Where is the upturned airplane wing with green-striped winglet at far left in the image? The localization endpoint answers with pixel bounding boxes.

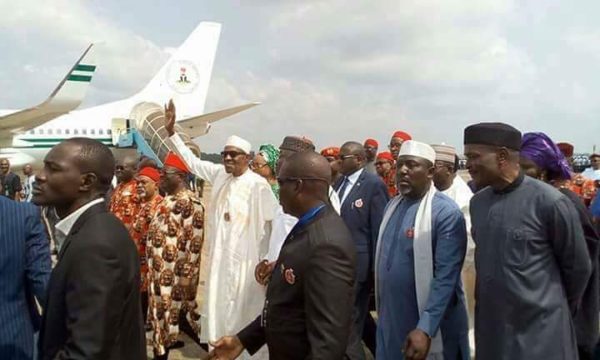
[0,44,96,140]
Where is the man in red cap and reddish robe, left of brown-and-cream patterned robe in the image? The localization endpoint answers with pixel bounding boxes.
[130,167,163,322]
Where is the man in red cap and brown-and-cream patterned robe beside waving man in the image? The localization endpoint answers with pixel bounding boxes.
[147,153,204,360]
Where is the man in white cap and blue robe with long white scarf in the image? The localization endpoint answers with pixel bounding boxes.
[375,140,470,360]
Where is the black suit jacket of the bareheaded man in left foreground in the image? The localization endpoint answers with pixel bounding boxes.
[40,203,146,360]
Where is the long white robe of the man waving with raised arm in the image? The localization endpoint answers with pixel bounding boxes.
[170,134,279,359]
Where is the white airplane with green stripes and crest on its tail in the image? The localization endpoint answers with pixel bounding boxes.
[0,22,258,168]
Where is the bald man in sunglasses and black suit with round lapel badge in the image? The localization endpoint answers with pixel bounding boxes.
[210,151,356,360]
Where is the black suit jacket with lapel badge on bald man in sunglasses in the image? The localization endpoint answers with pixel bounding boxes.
[238,207,356,360]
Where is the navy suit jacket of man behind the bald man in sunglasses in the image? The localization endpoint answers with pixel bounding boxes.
[335,170,390,282]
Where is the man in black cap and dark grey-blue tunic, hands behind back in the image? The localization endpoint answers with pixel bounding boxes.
[464,123,592,360]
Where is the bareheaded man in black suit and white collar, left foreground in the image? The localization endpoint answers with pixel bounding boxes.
[33,138,146,360]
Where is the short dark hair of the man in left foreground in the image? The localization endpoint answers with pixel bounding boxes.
[64,137,115,193]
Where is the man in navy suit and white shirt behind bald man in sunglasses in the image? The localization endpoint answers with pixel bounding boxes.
[335,141,389,360]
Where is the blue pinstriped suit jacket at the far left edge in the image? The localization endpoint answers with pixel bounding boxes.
[0,197,51,360]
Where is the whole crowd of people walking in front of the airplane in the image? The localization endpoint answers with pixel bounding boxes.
[0,102,600,360]
